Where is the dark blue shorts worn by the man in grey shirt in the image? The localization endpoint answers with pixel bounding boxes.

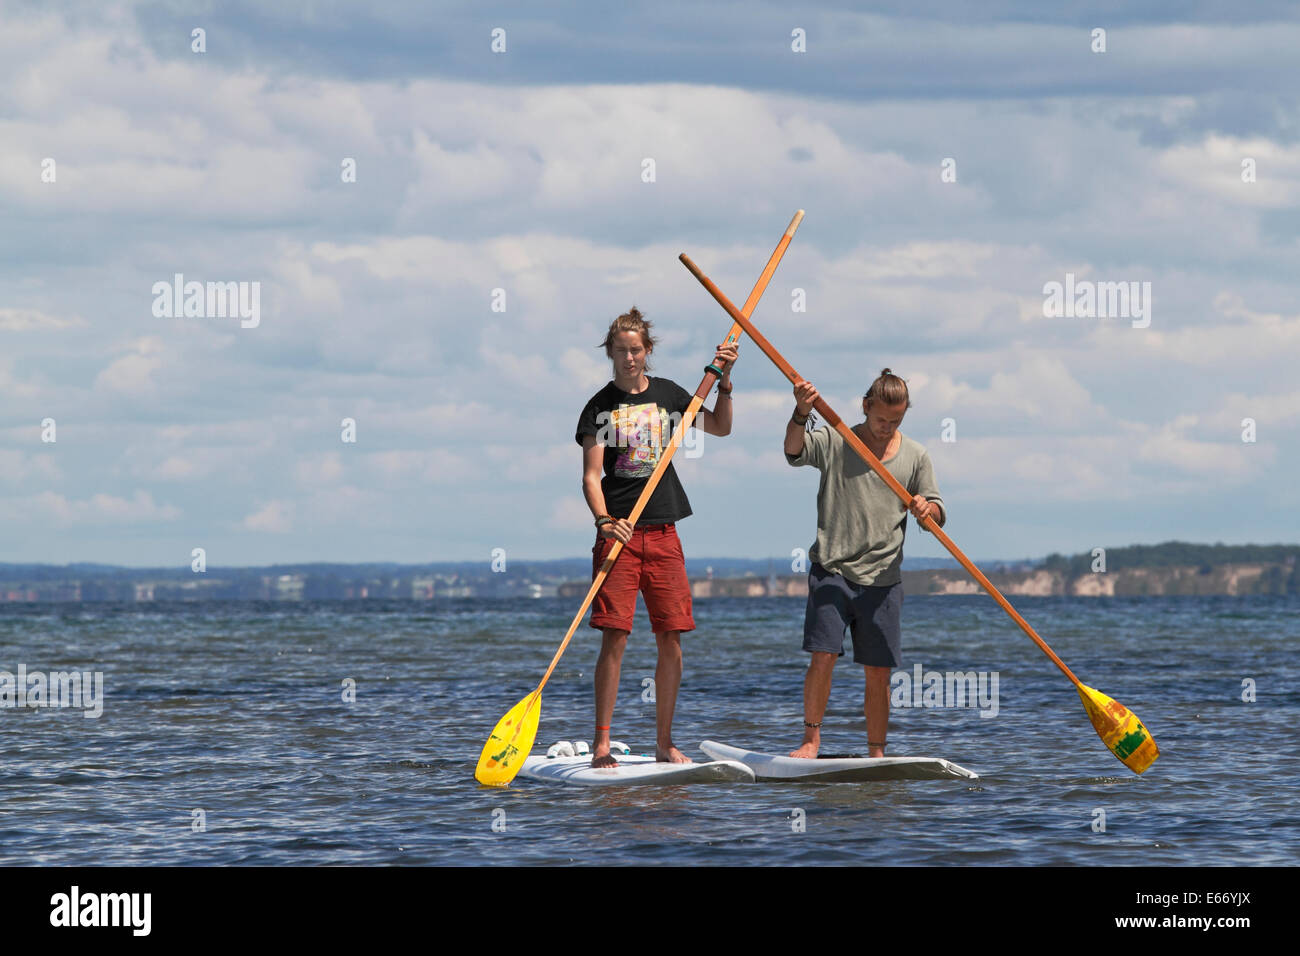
[803,563,902,667]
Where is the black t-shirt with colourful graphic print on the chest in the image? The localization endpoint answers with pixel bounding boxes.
[573,376,692,525]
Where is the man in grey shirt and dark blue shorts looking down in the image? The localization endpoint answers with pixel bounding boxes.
[785,368,948,757]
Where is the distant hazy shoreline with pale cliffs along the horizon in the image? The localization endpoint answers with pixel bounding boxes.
[0,541,1300,604]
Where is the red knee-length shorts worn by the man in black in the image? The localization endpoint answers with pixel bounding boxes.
[590,524,696,633]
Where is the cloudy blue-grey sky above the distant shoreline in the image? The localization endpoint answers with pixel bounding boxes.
[0,0,1300,566]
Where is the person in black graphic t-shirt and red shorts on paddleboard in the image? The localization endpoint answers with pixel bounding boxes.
[575,308,737,767]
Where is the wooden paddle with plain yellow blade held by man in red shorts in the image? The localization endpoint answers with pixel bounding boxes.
[475,209,803,787]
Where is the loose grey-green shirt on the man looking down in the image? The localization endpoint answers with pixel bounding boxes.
[785,428,948,587]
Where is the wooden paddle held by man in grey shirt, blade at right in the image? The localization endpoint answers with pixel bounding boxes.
[680,252,1160,774]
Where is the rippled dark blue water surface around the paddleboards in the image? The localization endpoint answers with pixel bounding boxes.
[0,596,1300,866]
